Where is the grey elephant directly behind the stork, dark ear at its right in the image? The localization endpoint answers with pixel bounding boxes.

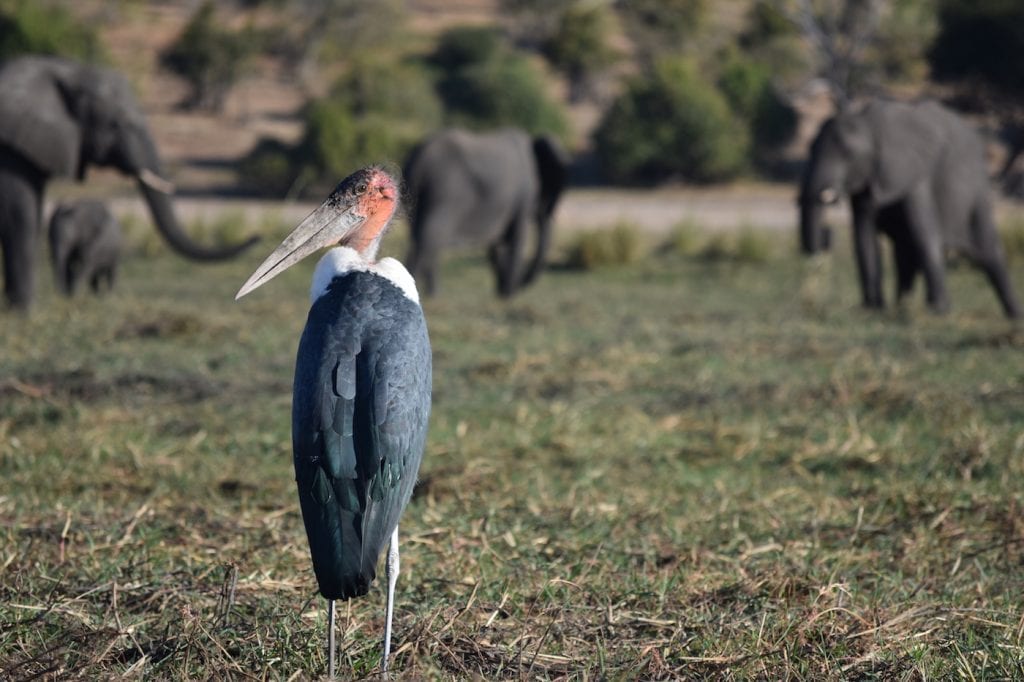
[404,128,567,297]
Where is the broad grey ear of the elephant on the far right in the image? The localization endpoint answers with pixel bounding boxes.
[865,101,944,204]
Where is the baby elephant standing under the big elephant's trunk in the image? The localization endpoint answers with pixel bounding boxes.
[50,200,121,296]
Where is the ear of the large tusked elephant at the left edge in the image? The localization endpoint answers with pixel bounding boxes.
[0,57,82,176]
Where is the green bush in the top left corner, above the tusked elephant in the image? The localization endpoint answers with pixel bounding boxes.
[0,0,105,61]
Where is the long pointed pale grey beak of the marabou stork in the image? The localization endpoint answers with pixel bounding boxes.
[234,200,366,301]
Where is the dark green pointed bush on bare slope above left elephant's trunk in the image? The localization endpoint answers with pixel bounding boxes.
[160,0,253,112]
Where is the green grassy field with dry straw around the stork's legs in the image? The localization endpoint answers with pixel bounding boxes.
[0,220,1024,680]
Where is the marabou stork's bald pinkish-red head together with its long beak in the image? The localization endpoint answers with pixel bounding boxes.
[234,166,398,300]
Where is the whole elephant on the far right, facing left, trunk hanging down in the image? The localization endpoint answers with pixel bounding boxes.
[799,99,1021,318]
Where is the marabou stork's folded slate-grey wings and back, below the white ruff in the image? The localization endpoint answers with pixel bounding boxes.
[292,272,431,599]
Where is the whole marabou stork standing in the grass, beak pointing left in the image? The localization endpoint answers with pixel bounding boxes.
[236,167,431,678]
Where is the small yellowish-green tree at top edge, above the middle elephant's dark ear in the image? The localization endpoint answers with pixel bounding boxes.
[543,2,620,101]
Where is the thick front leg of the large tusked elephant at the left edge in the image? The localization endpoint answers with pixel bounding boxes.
[0,162,42,309]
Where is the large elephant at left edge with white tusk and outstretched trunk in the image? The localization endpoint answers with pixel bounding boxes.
[0,56,259,309]
